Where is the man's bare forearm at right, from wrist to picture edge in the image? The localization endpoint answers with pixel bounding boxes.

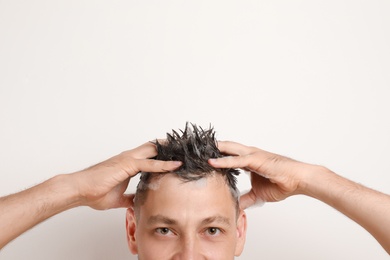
[301,166,390,254]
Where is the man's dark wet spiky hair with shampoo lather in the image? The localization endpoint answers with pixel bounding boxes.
[134,122,240,214]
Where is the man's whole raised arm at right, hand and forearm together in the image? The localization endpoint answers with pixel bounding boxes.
[209,142,390,254]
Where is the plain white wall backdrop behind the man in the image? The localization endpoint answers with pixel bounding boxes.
[0,0,390,260]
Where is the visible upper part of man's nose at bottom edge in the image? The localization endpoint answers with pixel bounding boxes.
[172,236,205,260]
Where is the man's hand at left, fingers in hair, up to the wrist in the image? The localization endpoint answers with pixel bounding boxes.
[71,142,181,210]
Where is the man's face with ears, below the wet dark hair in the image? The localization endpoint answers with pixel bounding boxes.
[126,174,246,260]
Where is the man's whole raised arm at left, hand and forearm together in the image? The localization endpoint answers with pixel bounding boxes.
[0,143,181,249]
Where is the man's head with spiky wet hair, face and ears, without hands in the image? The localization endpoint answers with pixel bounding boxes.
[127,124,246,260]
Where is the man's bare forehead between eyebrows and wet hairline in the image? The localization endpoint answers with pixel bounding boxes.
[140,174,236,220]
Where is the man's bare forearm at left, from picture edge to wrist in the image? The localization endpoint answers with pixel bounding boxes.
[0,175,79,249]
